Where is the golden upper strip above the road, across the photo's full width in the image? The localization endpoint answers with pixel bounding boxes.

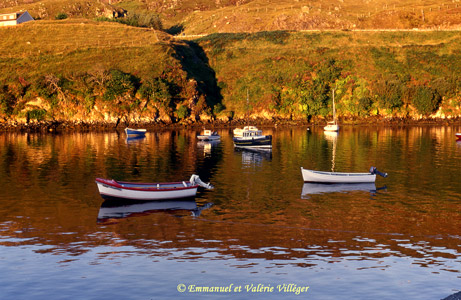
[0,0,461,34]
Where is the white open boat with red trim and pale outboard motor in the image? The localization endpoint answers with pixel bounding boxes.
[96,175,213,201]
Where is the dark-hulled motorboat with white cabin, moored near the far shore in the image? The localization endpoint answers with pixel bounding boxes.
[234,126,272,148]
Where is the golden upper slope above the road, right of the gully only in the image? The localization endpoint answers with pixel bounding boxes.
[178,0,461,34]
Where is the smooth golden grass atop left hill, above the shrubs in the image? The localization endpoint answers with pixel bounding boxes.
[0,20,174,79]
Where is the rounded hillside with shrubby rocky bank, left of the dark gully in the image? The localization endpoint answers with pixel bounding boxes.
[0,20,219,122]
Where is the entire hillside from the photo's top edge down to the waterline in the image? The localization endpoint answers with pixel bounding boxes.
[0,0,461,124]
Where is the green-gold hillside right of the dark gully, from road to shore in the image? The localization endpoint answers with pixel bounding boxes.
[196,31,461,119]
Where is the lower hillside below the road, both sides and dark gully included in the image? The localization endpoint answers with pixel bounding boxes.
[0,21,461,124]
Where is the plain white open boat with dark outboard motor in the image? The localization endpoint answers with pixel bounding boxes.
[301,167,387,183]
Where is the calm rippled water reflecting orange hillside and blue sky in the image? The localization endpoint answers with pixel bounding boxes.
[0,126,461,300]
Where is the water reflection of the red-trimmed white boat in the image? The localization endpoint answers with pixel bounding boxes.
[97,197,213,223]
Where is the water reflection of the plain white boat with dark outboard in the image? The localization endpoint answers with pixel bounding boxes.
[301,182,386,199]
